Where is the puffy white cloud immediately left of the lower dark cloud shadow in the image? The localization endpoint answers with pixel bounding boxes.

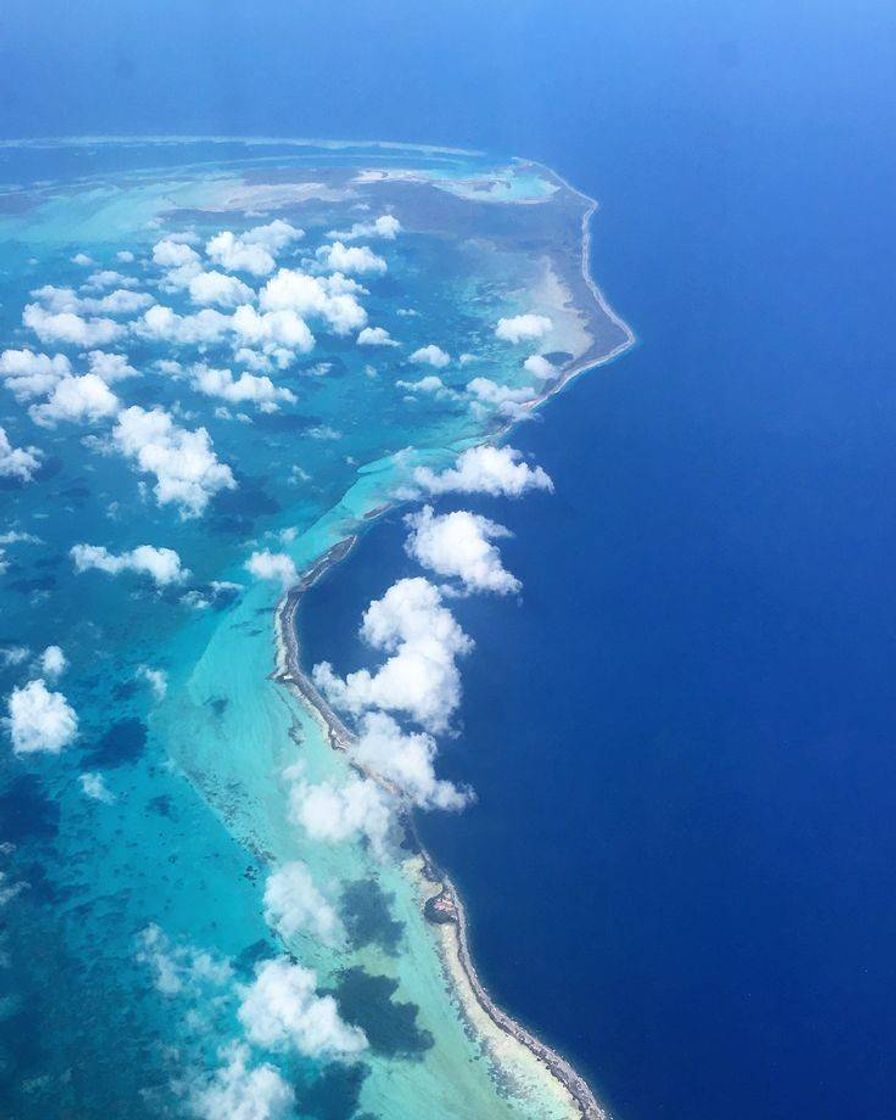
[237,956,367,1060]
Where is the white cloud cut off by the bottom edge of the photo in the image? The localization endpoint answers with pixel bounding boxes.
[190,1046,295,1120]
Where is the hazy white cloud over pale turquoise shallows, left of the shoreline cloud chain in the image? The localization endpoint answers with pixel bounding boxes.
[289,776,392,855]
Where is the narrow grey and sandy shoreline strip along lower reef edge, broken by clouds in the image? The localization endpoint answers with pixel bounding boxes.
[271,534,610,1120]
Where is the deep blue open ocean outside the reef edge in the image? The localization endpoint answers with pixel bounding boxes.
[0,0,896,1120]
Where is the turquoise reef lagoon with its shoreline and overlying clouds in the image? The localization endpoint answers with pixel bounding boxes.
[0,138,633,1120]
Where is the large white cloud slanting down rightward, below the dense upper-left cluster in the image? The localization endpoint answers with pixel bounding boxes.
[112,404,236,517]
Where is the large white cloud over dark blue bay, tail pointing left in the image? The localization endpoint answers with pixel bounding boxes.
[312,577,473,732]
